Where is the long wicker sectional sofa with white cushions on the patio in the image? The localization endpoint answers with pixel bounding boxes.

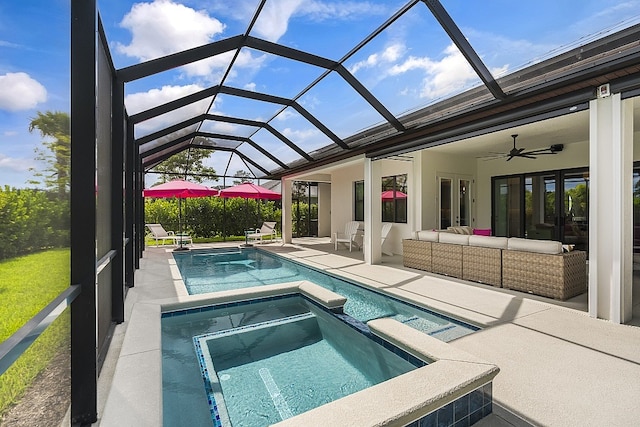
[403,231,587,300]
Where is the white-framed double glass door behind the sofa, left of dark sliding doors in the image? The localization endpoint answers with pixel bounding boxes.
[438,174,473,230]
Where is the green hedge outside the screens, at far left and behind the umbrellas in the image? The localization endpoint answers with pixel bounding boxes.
[0,186,307,260]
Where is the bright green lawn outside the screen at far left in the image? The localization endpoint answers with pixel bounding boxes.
[0,249,71,416]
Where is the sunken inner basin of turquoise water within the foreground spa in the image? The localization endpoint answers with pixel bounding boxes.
[194,302,416,426]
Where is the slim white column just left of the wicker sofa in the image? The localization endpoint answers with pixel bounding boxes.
[363,157,382,264]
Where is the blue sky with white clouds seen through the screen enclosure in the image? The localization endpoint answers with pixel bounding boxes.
[0,0,640,187]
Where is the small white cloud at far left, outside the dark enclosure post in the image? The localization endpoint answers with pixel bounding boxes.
[0,73,47,111]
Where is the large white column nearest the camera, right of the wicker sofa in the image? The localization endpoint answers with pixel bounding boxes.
[589,94,633,323]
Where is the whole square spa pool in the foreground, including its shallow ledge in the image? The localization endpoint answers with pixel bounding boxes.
[162,295,426,426]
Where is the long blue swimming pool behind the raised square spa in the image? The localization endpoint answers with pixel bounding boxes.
[174,248,479,342]
